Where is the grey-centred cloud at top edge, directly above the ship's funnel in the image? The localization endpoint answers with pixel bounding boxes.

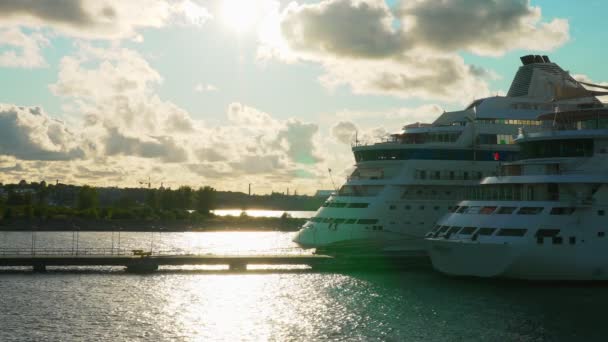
[400,0,570,56]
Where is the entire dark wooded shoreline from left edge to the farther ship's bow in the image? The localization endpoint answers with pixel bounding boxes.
[0,180,325,223]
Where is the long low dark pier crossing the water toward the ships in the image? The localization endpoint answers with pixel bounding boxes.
[0,250,428,273]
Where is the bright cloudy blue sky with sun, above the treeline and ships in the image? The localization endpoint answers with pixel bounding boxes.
[0,0,608,193]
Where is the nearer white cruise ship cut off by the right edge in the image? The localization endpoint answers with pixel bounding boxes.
[428,107,608,280]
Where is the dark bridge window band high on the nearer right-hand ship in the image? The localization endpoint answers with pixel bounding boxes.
[520,139,593,159]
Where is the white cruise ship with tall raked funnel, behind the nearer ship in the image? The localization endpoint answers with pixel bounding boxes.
[294,55,600,254]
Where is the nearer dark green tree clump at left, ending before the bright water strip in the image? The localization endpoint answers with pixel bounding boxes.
[0,181,216,221]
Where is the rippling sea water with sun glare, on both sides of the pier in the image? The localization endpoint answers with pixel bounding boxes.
[0,232,608,341]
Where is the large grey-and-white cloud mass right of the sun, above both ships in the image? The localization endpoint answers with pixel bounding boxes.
[258,0,569,103]
